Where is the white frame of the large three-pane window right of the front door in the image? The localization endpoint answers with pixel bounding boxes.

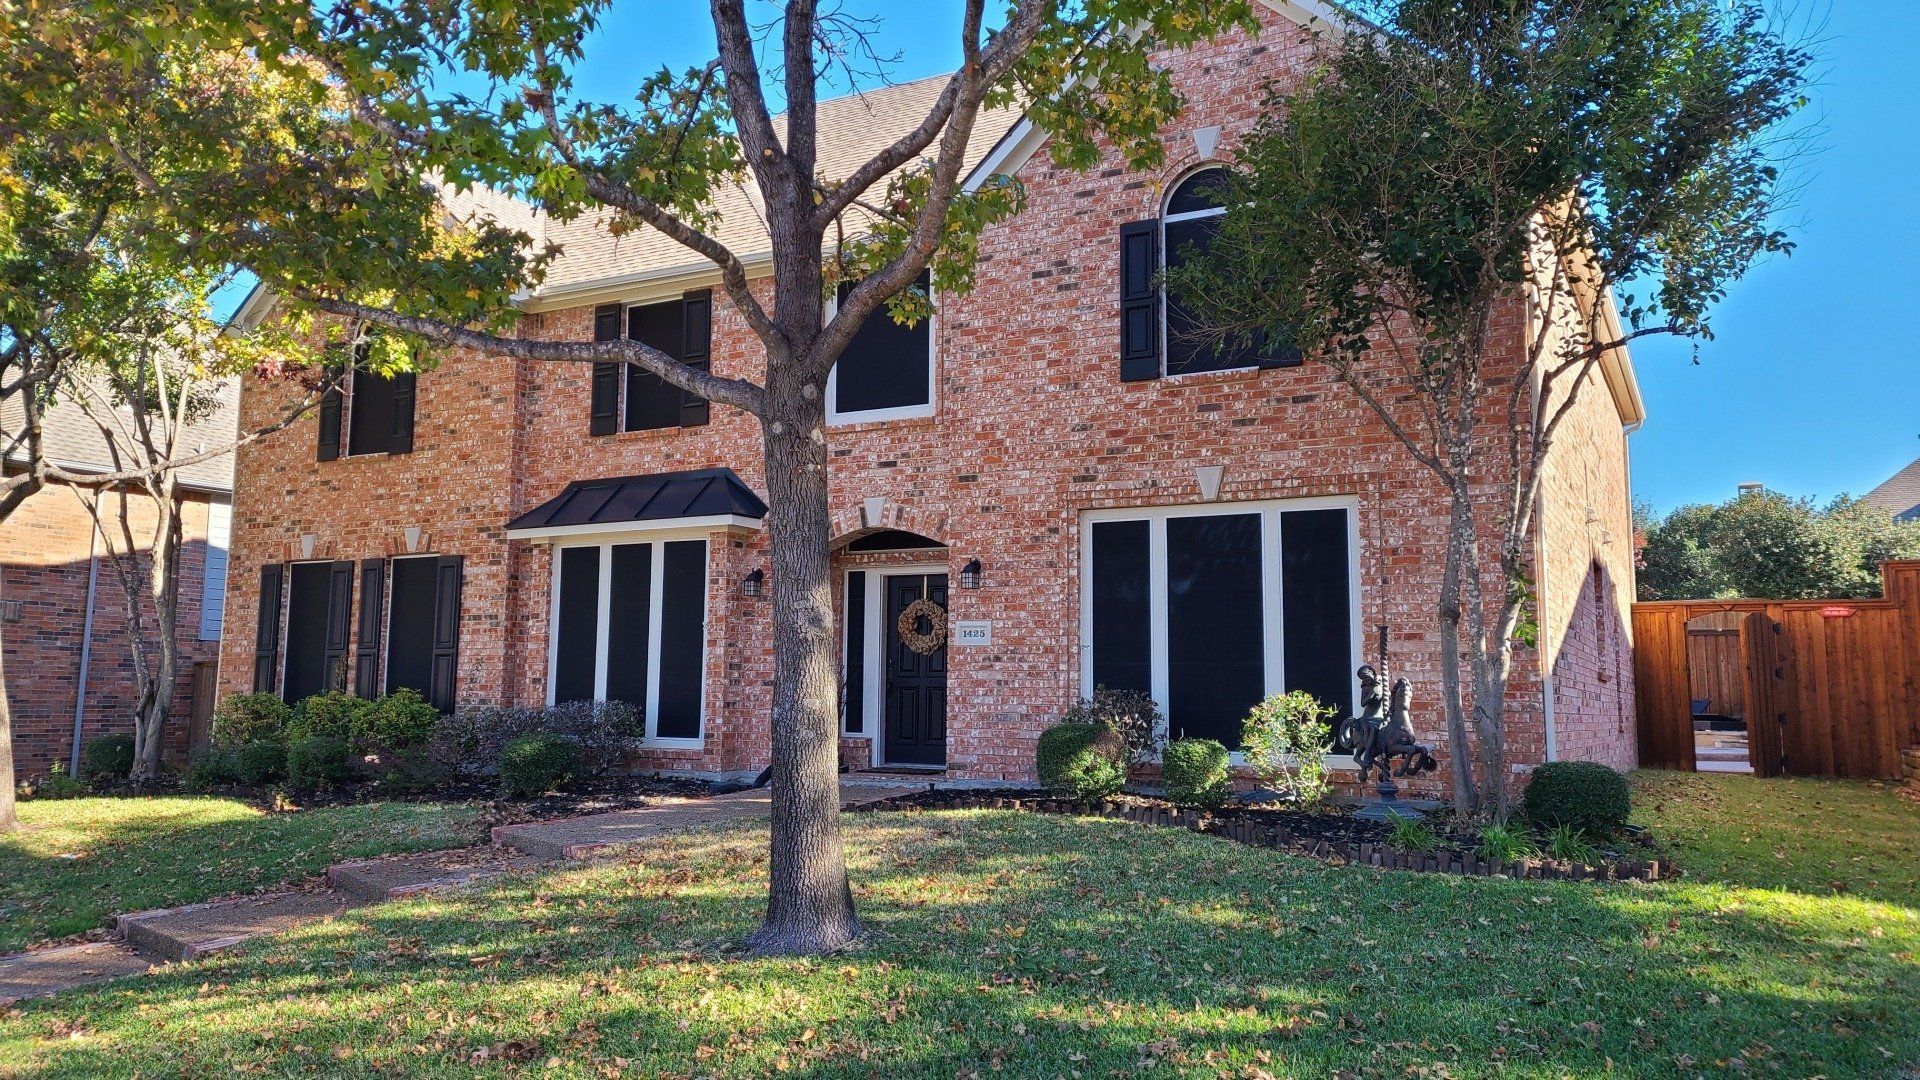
[1079,496,1365,769]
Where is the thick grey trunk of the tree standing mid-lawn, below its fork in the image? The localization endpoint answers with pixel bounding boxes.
[747,386,860,955]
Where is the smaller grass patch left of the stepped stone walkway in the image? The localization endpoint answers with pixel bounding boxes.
[0,798,480,955]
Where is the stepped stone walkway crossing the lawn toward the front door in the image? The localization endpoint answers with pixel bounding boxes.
[0,782,924,1005]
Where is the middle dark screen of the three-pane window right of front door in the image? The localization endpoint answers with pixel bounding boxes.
[1167,513,1265,749]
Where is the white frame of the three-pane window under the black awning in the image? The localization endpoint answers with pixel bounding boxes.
[547,528,714,749]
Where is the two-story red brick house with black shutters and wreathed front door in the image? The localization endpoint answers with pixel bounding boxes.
[221,0,1642,784]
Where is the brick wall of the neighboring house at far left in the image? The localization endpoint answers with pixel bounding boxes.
[0,472,217,778]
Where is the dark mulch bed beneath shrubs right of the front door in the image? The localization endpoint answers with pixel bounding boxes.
[858,790,1678,882]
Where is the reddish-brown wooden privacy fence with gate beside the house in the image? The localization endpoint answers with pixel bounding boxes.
[1634,561,1920,780]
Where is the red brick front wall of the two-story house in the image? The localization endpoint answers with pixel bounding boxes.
[223,6,1624,780]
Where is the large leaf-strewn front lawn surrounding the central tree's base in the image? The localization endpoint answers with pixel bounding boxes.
[0,768,1920,1078]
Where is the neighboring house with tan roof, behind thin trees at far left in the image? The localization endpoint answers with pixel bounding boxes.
[0,382,240,776]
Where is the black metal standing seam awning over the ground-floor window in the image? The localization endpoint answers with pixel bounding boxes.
[507,469,766,542]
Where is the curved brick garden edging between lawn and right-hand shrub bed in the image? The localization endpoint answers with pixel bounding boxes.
[858,796,1676,882]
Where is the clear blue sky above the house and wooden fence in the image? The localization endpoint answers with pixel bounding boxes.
[445,0,1920,511]
